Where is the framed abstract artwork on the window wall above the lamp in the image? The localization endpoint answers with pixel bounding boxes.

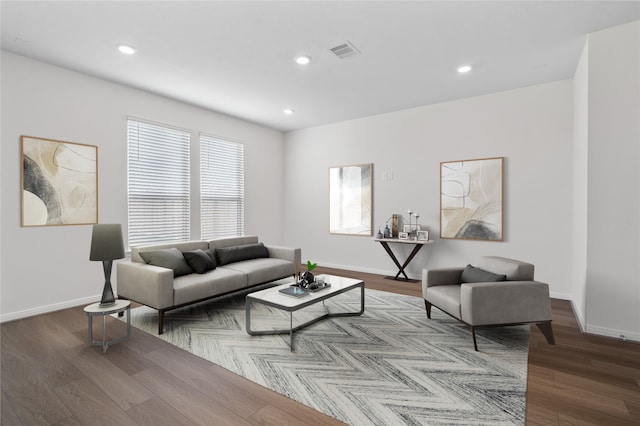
[20,135,98,227]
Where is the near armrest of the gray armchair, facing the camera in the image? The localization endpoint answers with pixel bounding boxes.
[460,281,551,325]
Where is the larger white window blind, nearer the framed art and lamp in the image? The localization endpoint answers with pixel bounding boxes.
[127,119,191,247]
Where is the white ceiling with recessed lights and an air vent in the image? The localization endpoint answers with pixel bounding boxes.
[0,0,640,131]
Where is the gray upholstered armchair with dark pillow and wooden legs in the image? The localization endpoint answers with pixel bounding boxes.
[422,256,555,351]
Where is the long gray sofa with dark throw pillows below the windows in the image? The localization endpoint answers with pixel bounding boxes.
[117,236,301,334]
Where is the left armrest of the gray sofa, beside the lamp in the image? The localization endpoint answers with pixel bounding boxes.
[117,262,173,309]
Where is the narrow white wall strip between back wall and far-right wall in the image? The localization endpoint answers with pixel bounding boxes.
[572,41,589,330]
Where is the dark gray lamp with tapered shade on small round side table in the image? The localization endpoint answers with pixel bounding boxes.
[89,223,124,306]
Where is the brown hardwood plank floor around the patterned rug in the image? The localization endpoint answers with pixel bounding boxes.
[0,268,640,426]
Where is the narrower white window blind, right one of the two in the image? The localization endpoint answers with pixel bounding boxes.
[200,135,244,240]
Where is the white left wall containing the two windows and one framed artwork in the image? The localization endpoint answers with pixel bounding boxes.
[0,51,284,321]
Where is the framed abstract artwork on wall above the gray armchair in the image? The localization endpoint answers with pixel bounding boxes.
[440,157,504,241]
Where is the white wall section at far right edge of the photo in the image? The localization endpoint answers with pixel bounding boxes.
[586,21,640,341]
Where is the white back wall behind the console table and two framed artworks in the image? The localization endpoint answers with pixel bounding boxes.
[284,80,573,298]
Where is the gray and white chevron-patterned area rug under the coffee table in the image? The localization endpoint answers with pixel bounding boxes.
[125,290,529,426]
